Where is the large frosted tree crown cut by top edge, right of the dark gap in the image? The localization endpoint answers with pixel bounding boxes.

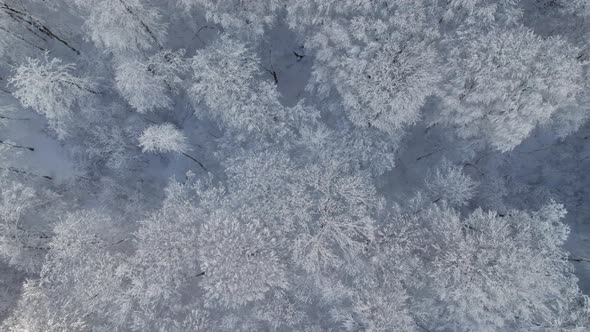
[289,1,439,134]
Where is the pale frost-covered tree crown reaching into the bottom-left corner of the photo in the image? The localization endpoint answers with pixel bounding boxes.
[4,211,125,331]
